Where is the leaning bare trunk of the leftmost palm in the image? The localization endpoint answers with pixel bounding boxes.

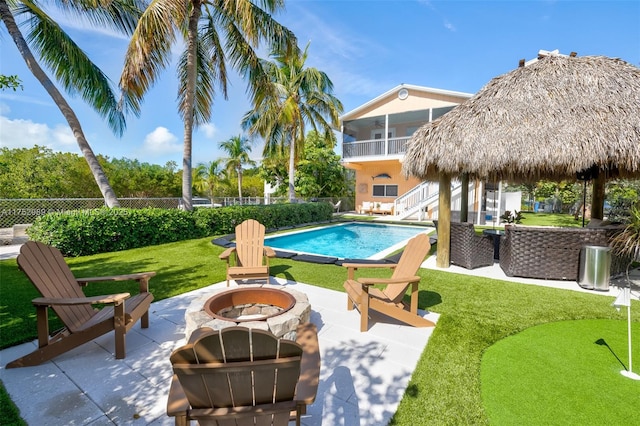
[0,0,120,207]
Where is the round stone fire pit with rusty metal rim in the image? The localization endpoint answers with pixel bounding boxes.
[185,285,311,340]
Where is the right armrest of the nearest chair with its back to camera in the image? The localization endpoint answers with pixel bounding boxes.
[296,323,320,404]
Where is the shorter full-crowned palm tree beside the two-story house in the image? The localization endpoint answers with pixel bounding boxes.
[242,44,342,202]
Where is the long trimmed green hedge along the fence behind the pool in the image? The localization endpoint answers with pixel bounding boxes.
[27,203,333,256]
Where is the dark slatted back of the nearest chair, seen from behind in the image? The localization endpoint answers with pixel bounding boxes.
[171,327,302,412]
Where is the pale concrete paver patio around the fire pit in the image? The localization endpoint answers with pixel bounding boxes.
[0,278,438,426]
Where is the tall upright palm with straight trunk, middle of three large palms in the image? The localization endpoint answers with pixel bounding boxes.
[120,0,295,210]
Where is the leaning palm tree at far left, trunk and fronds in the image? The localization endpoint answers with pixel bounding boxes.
[0,0,139,207]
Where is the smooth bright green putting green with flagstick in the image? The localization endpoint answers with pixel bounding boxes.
[480,320,640,426]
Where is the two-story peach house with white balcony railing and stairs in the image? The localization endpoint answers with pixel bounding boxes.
[340,84,478,218]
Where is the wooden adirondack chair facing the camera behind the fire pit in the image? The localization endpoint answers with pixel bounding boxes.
[219,219,276,287]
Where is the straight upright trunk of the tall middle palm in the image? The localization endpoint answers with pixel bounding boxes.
[182,0,202,210]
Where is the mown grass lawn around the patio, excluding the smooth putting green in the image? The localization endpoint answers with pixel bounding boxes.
[0,216,640,425]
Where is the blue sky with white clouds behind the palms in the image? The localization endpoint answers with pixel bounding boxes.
[0,0,640,164]
